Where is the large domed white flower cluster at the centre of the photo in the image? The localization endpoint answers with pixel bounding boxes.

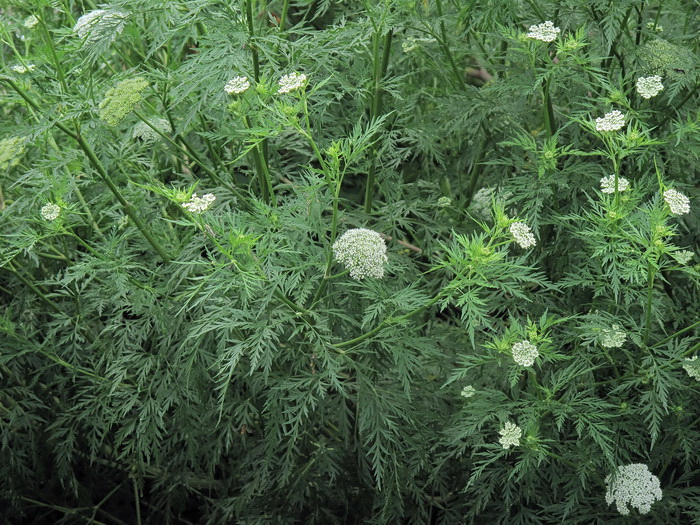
[333,228,388,281]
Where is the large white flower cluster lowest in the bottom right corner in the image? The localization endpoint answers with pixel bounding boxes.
[605,463,661,516]
